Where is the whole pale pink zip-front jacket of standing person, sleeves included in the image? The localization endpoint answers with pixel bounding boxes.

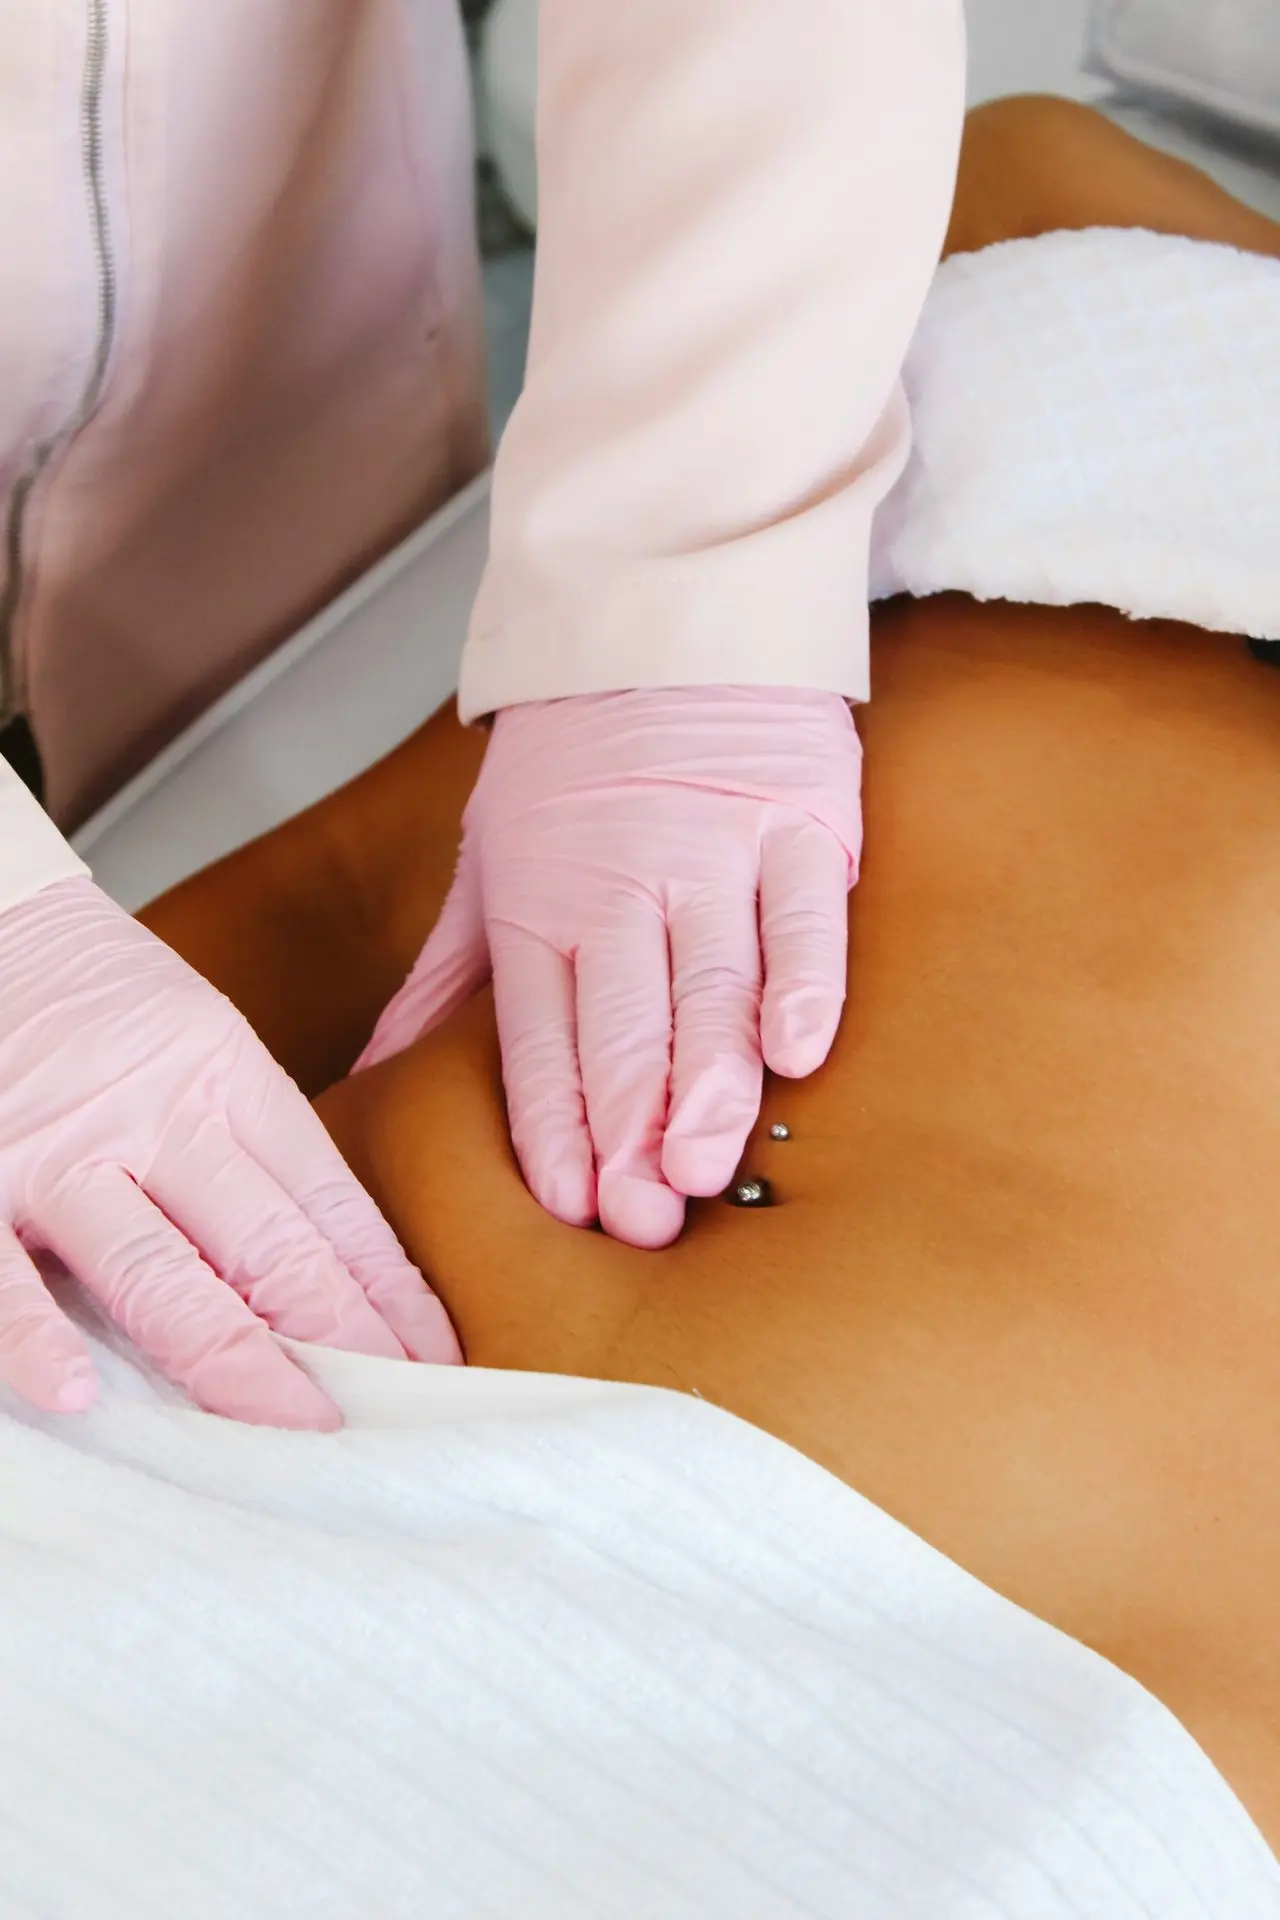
[0,0,963,908]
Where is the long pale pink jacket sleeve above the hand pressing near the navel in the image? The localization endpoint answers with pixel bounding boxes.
[461,0,965,718]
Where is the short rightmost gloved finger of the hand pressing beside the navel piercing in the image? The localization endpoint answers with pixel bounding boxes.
[760,820,850,1079]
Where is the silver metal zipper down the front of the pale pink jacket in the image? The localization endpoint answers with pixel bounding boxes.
[0,0,117,726]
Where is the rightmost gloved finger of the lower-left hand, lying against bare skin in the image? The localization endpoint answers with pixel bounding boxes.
[228,1054,462,1365]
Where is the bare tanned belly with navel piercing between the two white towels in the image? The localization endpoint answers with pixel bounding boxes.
[326,599,1280,1851]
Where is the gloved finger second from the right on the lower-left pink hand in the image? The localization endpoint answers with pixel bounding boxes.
[146,1119,405,1359]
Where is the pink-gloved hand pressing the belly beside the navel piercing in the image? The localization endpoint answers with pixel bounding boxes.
[357,687,862,1246]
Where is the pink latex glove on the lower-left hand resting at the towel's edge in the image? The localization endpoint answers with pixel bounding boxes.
[0,879,461,1428]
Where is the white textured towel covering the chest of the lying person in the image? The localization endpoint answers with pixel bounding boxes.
[871,228,1280,639]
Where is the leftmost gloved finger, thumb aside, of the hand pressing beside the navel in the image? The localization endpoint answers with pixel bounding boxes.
[491,925,597,1227]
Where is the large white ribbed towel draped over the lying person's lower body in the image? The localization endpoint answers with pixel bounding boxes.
[0,1297,1280,1920]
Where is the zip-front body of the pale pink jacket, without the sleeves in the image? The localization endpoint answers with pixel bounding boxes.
[0,0,487,840]
